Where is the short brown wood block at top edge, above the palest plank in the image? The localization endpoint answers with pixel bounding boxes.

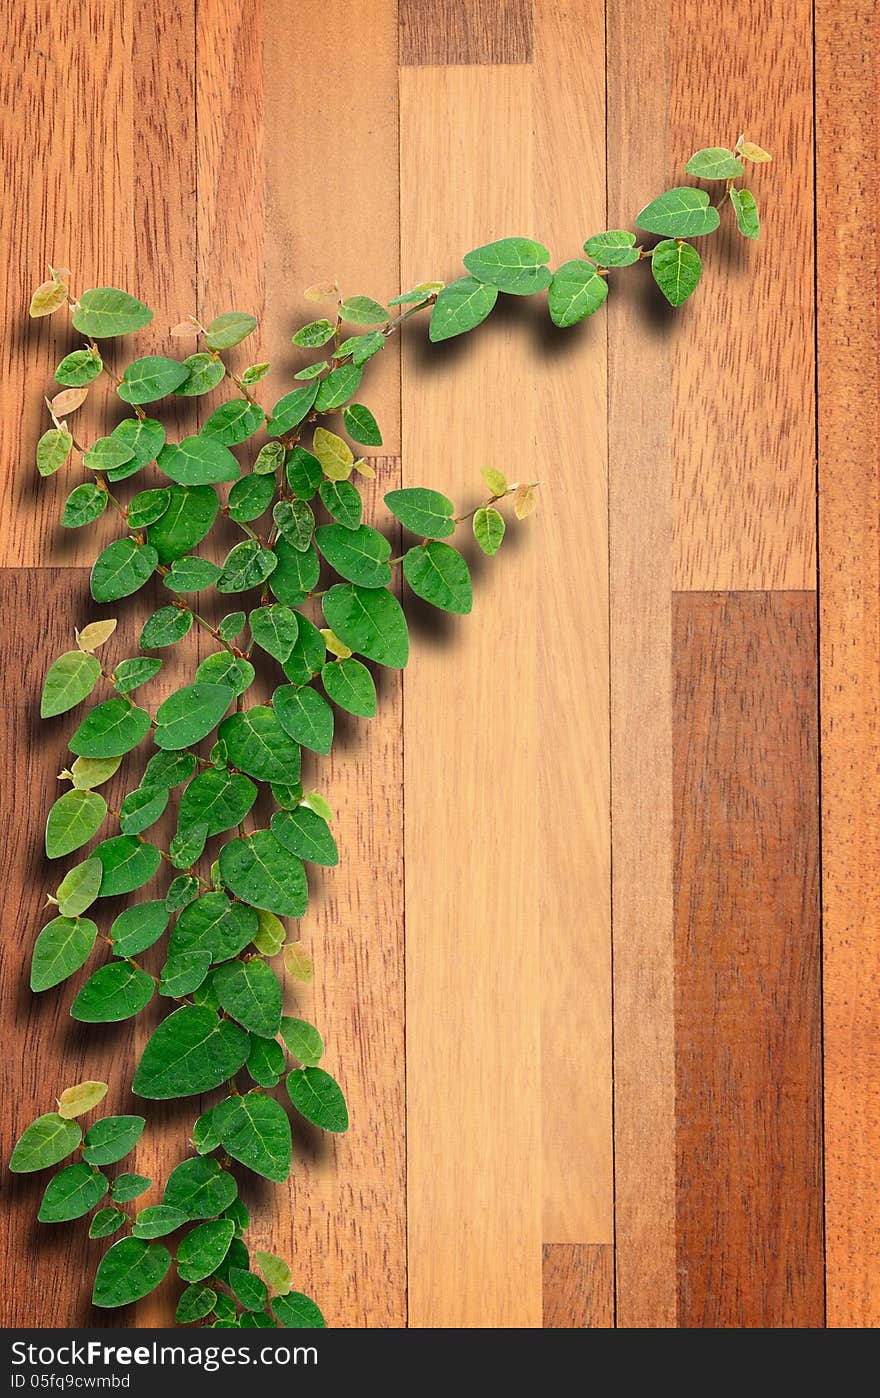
[399,0,528,64]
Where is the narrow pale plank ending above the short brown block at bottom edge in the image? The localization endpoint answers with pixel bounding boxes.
[525,0,614,1243]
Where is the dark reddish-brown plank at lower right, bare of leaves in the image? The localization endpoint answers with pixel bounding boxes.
[673,593,824,1329]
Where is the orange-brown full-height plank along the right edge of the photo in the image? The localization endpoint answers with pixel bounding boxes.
[816,0,880,1328]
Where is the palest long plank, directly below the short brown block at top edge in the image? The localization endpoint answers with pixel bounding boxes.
[400,67,548,1327]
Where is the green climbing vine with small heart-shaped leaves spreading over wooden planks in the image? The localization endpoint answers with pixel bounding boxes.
[10,138,769,1328]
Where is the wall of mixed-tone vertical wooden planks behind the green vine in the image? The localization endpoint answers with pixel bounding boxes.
[0,0,880,1328]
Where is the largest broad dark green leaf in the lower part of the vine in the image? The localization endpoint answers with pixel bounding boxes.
[132,1005,250,1101]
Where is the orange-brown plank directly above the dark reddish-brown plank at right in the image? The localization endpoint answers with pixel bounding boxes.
[668,0,816,590]
